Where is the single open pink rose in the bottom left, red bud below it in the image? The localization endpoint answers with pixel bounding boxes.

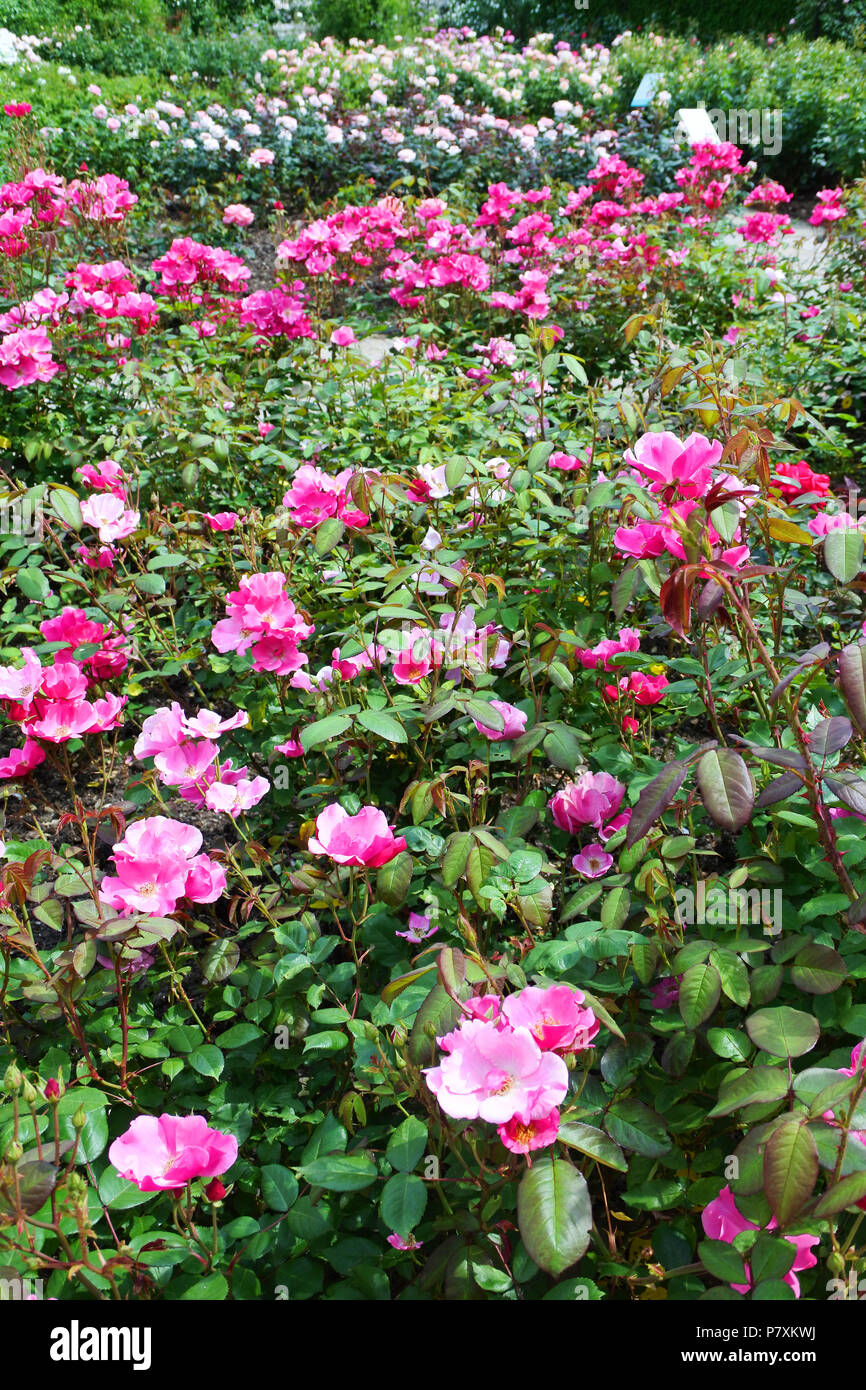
[108,1115,238,1193]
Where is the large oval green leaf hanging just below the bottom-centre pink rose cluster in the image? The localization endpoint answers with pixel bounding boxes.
[517,1158,592,1276]
